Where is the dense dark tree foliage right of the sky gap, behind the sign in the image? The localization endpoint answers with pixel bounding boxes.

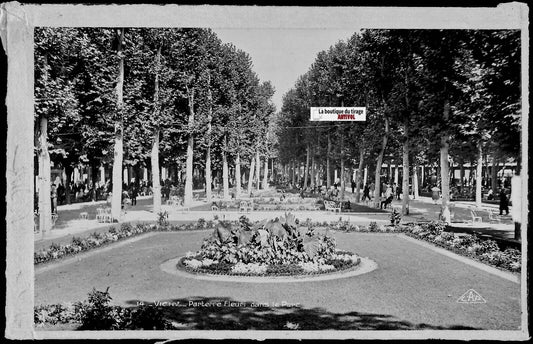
[276,29,521,214]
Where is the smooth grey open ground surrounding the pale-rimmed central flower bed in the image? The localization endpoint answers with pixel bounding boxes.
[35,232,520,330]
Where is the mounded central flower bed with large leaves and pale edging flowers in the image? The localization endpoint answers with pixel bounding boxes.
[177,214,360,276]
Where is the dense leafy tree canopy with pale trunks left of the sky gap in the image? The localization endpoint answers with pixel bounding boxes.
[35,28,275,222]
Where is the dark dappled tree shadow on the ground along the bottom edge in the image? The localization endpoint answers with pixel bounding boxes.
[127,297,476,330]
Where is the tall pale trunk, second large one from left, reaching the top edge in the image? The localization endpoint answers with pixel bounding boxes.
[111,29,124,220]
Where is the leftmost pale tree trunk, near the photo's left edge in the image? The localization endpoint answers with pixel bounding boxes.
[39,116,52,234]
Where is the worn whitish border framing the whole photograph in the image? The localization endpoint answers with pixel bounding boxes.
[0,2,529,340]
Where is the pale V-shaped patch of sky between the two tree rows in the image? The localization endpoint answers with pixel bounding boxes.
[213,28,359,111]
